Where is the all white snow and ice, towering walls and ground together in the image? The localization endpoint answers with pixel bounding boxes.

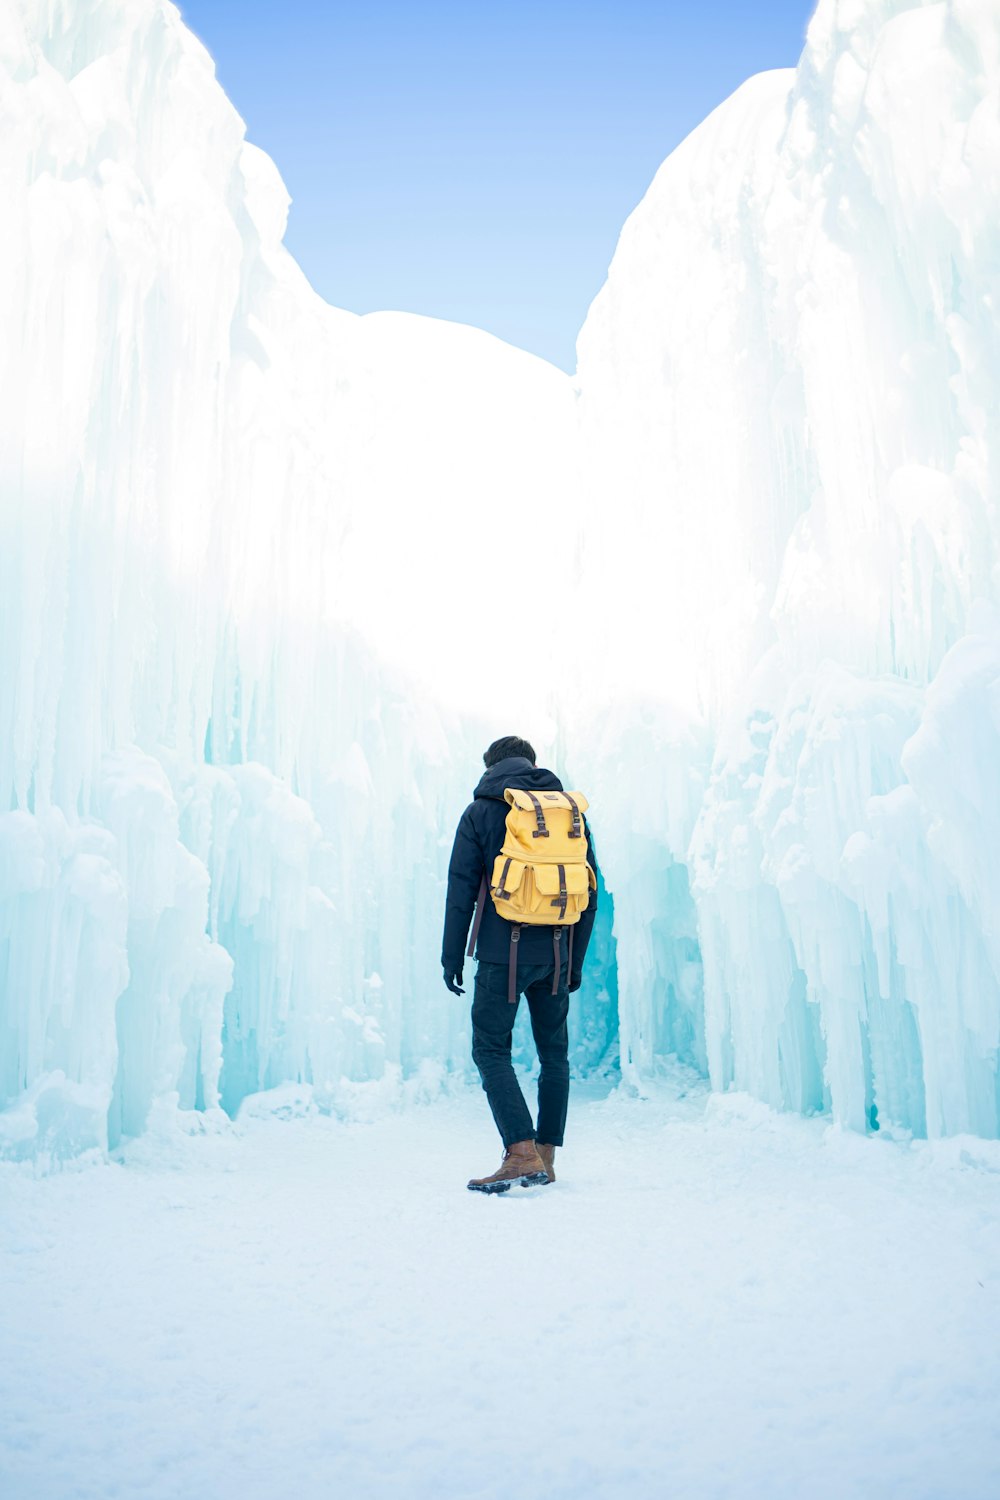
[0,0,1000,1500]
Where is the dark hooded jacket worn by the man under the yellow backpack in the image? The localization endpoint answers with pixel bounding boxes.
[441,756,597,981]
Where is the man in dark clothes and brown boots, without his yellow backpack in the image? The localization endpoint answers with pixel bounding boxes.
[441,735,597,1193]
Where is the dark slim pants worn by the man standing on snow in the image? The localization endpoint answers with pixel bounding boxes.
[472,962,570,1146]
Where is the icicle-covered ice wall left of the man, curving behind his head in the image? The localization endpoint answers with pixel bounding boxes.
[0,0,593,1160]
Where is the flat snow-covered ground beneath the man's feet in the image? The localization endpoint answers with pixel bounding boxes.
[0,1079,1000,1500]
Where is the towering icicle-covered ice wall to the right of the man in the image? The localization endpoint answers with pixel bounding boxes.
[579,0,1000,1136]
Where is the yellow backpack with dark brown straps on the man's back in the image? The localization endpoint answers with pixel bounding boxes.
[468,786,597,1005]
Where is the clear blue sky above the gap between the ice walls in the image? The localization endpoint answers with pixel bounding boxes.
[181,0,813,371]
